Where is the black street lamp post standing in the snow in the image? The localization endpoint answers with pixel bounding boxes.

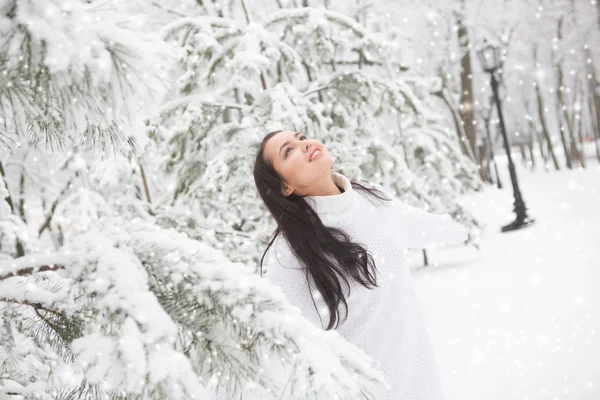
[477,44,535,232]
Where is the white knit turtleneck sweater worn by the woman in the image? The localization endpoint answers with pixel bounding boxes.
[265,173,467,400]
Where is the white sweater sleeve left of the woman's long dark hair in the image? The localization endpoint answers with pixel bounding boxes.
[265,238,329,329]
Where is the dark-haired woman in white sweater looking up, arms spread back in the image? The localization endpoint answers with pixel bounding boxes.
[254,130,467,400]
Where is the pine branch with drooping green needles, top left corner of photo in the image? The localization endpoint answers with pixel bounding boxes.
[0,1,166,154]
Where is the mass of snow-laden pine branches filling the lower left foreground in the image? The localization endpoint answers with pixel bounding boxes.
[0,219,383,400]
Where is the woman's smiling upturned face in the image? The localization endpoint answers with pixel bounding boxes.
[264,131,333,196]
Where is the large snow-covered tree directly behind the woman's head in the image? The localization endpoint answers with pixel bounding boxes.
[149,2,481,272]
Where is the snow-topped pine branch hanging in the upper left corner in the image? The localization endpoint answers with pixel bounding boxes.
[0,0,171,153]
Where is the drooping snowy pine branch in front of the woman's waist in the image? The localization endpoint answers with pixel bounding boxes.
[129,220,382,399]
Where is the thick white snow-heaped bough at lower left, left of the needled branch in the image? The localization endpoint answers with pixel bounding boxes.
[55,228,208,399]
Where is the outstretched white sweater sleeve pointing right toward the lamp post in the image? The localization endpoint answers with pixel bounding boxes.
[375,184,468,249]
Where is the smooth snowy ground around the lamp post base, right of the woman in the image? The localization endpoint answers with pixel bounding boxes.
[413,155,600,400]
